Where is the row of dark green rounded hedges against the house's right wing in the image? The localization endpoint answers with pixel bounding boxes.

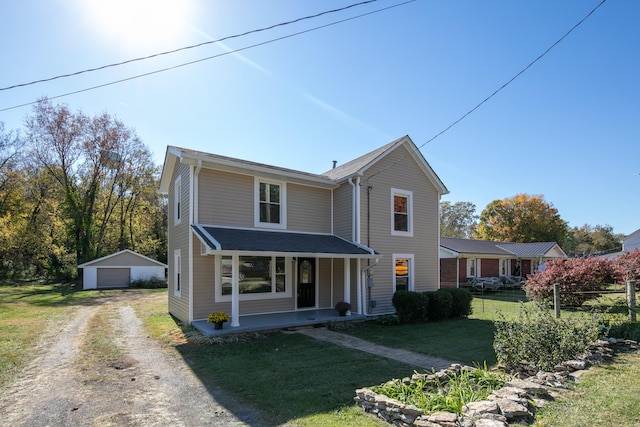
[392,288,473,323]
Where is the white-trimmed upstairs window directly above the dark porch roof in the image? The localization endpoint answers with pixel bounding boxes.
[255,178,286,228]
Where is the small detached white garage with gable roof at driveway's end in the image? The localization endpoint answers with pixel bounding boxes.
[78,249,167,289]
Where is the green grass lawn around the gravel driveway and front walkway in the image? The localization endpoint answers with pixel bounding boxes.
[0,285,640,427]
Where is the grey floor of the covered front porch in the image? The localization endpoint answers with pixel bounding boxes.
[192,308,367,337]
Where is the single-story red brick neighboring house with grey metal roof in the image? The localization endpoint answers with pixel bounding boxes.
[440,237,567,288]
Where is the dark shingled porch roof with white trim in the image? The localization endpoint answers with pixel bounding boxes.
[193,224,380,258]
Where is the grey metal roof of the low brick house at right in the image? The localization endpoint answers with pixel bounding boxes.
[440,237,567,258]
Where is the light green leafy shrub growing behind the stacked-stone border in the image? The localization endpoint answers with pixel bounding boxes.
[493,303,601,371]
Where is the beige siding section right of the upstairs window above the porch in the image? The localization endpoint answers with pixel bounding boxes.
[287,184,331,233]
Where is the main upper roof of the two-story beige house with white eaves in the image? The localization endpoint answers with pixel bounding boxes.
[159,136,449,195]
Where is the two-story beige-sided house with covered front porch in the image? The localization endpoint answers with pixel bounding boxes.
[160,136,447,327]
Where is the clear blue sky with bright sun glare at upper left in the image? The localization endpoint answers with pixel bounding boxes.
[0,0,640,235]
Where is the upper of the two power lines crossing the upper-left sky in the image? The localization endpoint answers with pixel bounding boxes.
[0,0,378,91]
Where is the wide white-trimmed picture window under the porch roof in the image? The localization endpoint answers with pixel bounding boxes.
[216,255,292,301]
